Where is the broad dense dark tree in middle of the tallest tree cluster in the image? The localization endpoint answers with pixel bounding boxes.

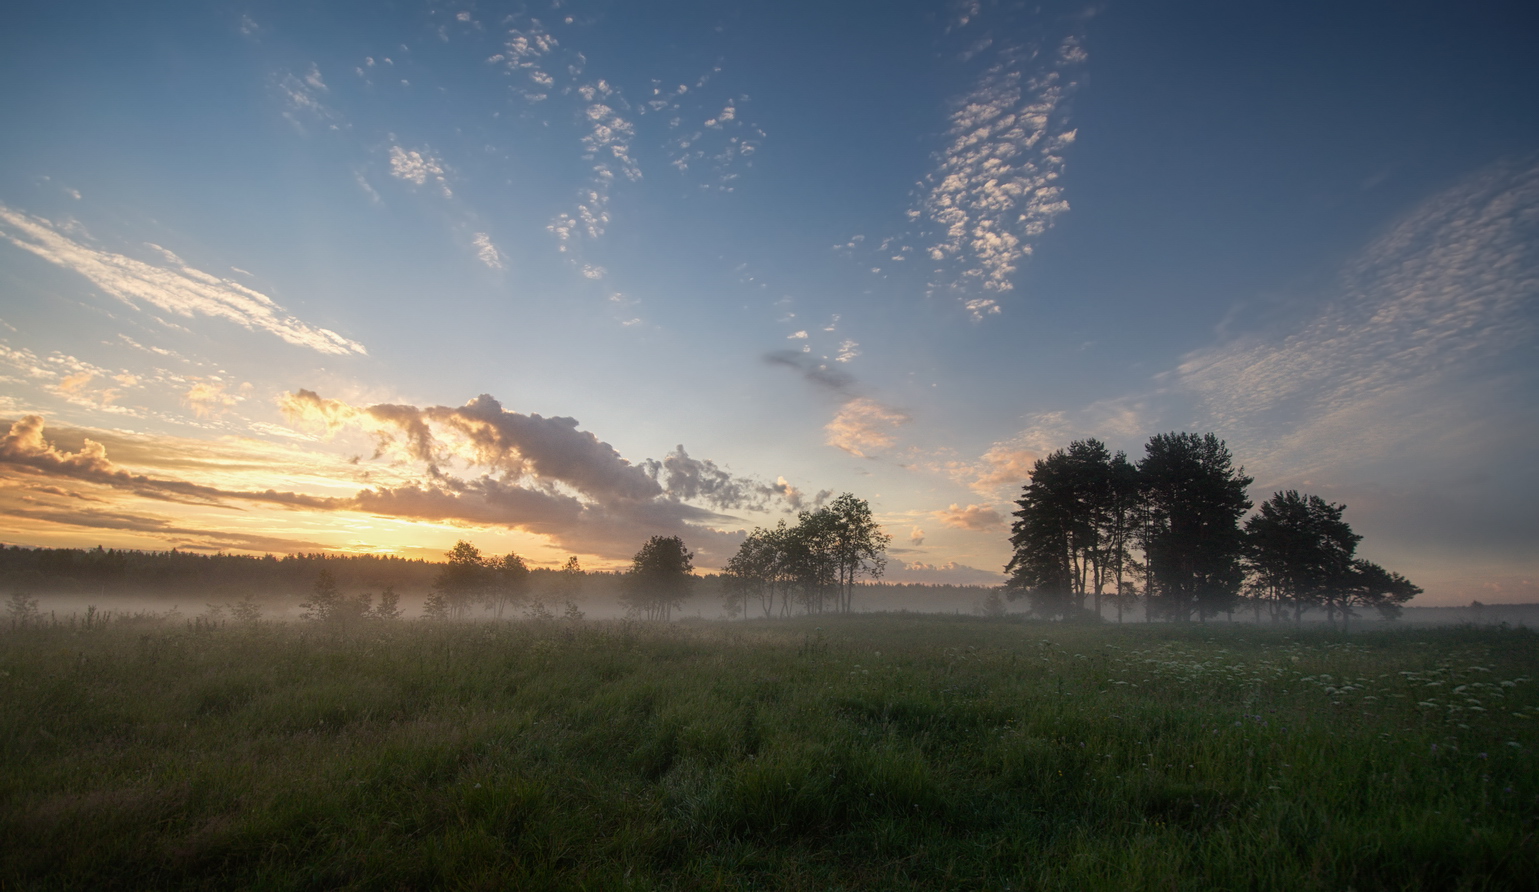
[1137,434,1253,620]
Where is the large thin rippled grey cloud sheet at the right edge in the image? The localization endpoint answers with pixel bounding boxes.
[1163,163,1539,472]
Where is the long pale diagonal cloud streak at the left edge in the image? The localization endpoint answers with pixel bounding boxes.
[0,205,368,355]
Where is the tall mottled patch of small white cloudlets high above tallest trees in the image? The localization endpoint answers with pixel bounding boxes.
[919,32,1085,320]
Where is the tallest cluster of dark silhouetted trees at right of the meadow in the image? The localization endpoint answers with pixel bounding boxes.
[1005,434,1420,623]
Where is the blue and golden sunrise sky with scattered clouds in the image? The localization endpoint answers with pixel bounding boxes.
[0,0,1539,604]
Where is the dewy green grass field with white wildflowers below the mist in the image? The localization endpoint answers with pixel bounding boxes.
[0,615,1539,890]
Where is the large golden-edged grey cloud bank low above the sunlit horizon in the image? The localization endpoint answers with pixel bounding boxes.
[0,402,769,566]
